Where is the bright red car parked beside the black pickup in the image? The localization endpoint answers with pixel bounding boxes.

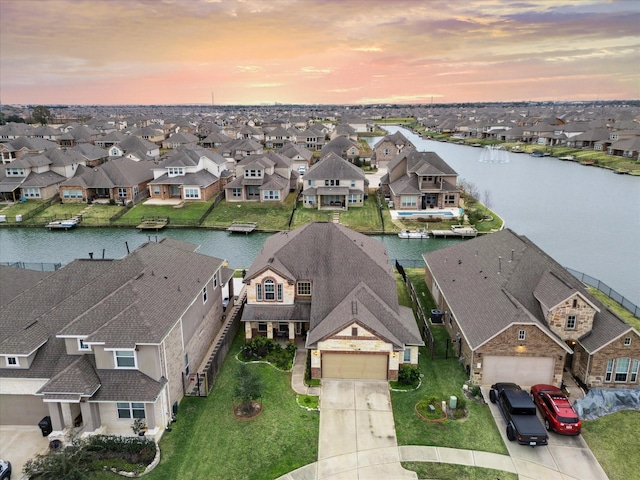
[531,384,582,435]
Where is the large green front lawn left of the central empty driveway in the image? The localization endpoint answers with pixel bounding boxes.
[146,331,319,480]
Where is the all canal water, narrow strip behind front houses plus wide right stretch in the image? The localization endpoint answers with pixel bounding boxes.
[0,127,640,305]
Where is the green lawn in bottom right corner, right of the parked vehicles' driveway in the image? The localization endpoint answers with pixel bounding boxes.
[582,410,640,480]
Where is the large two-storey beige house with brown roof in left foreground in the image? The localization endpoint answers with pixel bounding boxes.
[0,238,231,440]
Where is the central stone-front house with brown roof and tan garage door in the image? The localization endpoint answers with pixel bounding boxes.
[242,222,424,380]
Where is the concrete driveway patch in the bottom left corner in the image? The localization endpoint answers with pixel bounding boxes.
[0,425,49,480]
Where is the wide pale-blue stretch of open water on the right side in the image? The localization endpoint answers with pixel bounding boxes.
[368,127,640,305]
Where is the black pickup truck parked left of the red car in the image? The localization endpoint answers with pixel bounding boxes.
[489,382,549,447]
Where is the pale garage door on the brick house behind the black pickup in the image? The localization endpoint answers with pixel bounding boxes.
[482,355,555,386]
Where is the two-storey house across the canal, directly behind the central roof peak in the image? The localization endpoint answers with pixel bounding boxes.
[302,153,369,210]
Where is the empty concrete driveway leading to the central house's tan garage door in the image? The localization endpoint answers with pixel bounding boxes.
[315,379,418,480]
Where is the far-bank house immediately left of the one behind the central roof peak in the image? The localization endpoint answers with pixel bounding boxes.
[225,151,298,203]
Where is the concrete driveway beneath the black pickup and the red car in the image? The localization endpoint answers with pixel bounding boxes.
[482,387,609,480]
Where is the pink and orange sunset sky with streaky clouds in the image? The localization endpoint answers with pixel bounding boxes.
[0,0,640,105]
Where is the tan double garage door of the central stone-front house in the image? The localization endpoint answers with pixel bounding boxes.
[322,352,389,380]
